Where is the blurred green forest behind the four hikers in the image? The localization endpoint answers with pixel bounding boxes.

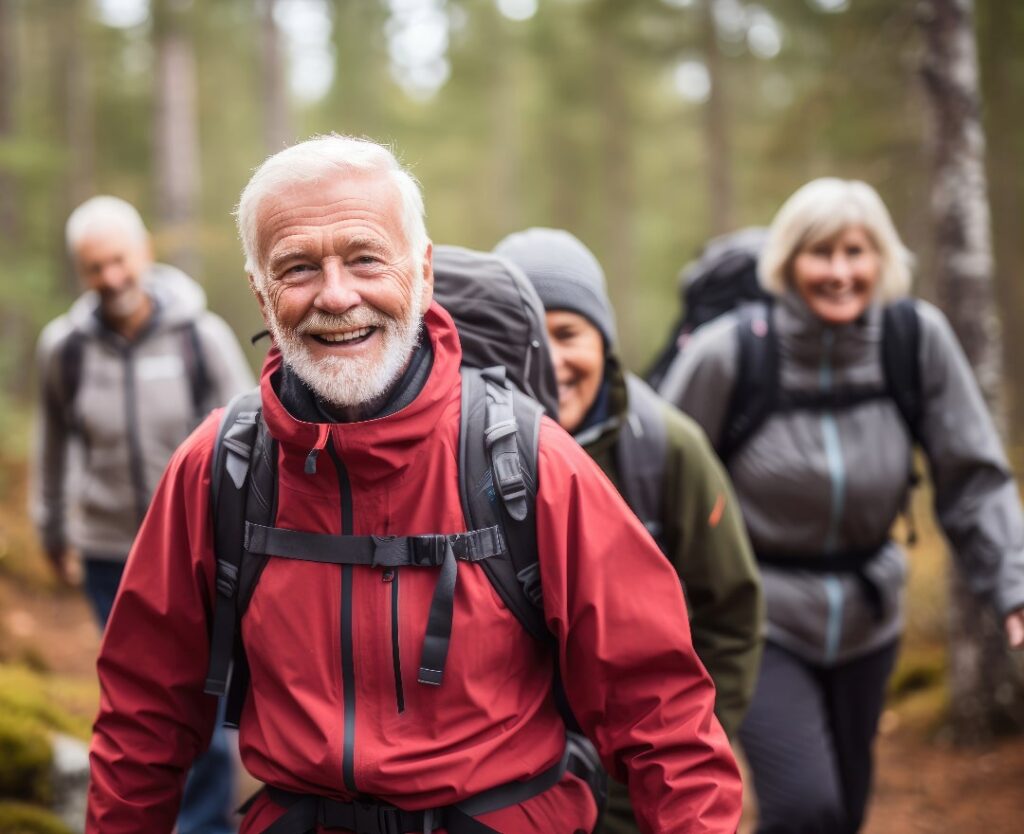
[0,0,1024,832]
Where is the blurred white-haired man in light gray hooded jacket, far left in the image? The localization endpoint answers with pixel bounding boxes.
[32,197,254,834]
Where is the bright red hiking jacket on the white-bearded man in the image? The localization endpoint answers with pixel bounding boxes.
[87,304,741,834]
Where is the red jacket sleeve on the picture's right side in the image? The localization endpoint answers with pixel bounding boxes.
[537,419,741,834]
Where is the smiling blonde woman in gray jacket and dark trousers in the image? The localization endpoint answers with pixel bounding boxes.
[660,178,1024,834]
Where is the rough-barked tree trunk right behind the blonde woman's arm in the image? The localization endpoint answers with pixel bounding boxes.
[919,0,1024,744]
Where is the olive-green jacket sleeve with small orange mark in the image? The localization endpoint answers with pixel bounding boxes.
[665,406,764,737]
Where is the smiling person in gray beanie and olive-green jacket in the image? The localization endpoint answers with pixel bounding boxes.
[495,228,763,834]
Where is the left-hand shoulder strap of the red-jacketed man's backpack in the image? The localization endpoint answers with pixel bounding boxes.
[204,388,262,713]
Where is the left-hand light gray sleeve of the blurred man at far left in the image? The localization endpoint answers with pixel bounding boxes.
[29,320,71,552]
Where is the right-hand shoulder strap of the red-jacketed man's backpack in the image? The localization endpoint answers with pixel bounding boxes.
[459,367,550,640]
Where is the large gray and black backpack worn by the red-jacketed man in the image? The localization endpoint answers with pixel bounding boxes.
[205,246,605,812]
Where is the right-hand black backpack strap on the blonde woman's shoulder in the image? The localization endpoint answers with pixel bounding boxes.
[882,298,925,444]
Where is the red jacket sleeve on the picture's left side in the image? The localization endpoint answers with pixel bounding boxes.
[86,413,224,834]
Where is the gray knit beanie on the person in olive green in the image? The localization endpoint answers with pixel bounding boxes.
[495,228,615,347]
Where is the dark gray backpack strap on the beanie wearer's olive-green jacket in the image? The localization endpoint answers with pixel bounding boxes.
[615,374,669,552]
